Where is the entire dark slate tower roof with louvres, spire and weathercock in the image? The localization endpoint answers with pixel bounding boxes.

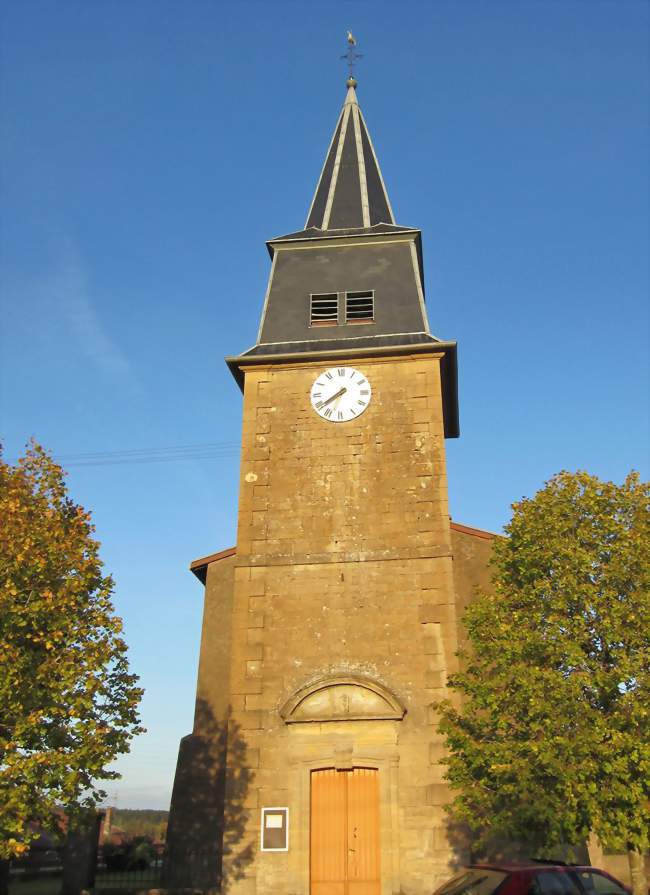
[228,50,458,438]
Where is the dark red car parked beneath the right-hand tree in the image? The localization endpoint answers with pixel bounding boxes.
[433,861,631,895]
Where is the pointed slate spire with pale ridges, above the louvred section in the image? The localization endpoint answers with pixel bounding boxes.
[305,76,395,230]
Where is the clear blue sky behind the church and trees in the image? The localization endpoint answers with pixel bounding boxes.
[0,0,650,807]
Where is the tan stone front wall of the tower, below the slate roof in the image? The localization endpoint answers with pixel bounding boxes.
[224,355,464,895]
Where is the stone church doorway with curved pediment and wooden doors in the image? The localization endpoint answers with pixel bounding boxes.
[280,672,406,895]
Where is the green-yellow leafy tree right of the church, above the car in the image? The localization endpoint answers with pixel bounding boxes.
[438,472,650,895]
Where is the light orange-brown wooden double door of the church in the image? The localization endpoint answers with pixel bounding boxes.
[310,768,381,895]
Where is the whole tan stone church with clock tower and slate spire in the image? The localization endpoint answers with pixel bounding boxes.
[164,77,494,895]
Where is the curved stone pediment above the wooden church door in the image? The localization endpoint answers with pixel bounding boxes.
[280,675,406,724]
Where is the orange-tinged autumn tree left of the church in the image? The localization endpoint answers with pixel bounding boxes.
[0,443,142,860]
